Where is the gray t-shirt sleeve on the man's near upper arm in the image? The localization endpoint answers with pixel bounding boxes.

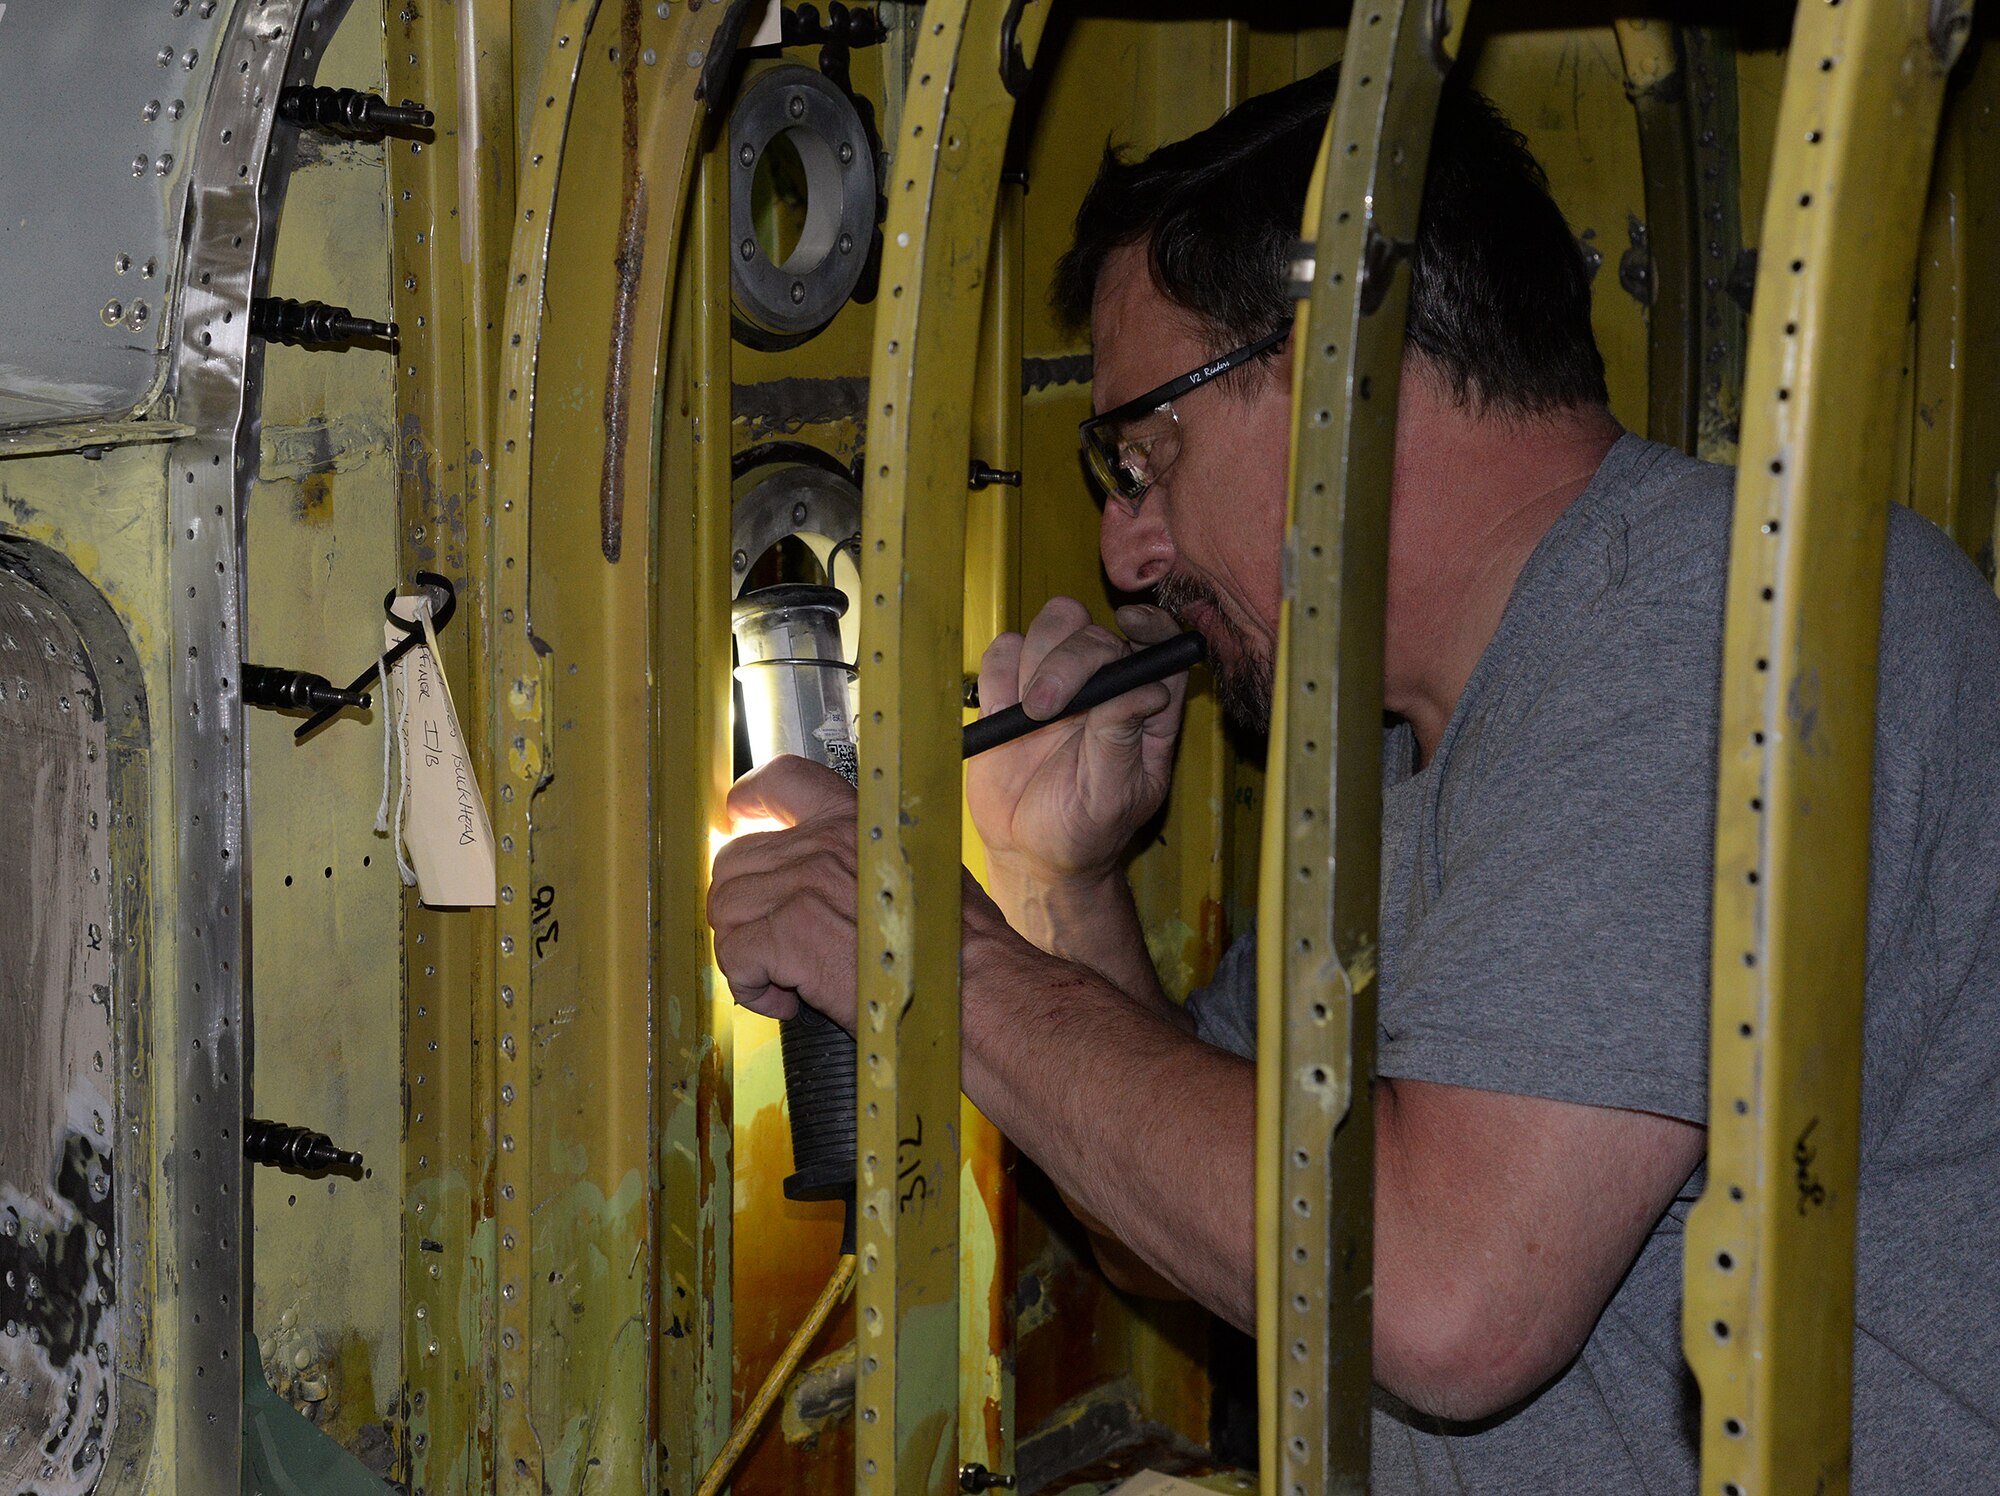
[1376,602,1720,1122]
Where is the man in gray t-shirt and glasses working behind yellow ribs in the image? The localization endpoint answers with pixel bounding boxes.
[710,74,2000,1496]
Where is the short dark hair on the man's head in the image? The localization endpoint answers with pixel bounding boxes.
[1054,68,1608,414]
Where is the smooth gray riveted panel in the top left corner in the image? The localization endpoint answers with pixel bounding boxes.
[0,0,232,428]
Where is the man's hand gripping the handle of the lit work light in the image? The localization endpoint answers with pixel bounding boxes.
[708,758,856,1034]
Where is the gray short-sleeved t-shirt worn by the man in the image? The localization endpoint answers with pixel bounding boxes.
[1188,436,2000,1496]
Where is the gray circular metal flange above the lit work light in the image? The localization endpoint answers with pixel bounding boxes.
[730,62,876,336]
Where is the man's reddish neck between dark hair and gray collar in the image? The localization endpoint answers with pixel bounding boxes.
[1384,378,1620,762]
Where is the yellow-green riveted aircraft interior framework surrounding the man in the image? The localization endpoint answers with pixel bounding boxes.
[0,0,2000,1496]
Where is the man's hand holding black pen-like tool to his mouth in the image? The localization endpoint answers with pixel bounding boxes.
[966,598,1188,884]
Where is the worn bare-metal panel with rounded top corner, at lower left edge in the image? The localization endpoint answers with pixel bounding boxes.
[0,570,118,1496]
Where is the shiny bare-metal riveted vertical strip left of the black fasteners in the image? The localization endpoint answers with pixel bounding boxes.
[165,0,344,1492]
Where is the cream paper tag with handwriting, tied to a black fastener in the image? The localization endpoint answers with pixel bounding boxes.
[382,598,494,908]
